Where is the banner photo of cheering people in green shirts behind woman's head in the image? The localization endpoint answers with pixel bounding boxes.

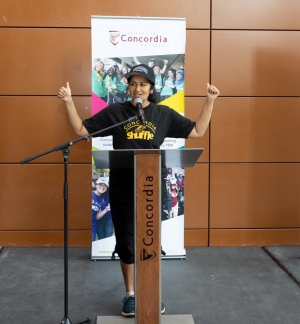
[92,54,184,111]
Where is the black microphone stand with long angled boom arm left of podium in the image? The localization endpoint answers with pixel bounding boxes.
[20,116,138,324]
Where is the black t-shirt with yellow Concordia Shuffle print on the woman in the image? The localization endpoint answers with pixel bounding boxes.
[83,101,195,149]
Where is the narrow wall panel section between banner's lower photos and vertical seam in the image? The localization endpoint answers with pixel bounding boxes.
[184,163,208,229]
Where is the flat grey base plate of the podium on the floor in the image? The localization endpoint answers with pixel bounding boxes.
[96,315,195,324]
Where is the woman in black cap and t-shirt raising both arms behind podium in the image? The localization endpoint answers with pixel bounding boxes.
[58,64,219,317]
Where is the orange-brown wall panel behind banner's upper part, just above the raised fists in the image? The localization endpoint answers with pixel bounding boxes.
[0,28,209,96]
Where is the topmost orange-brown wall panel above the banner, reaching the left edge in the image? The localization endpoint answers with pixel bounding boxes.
[0,0,210,28]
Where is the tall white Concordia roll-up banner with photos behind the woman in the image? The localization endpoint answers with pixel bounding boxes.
[91,16,186,259]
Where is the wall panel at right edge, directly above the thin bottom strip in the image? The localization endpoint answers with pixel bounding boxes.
[210,163,300,229]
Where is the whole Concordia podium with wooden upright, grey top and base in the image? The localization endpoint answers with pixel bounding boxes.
[92,149,203,324]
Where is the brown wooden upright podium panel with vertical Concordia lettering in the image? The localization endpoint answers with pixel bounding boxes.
[135,153,161,324]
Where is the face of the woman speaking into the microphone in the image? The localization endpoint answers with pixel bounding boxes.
[129,75,151,107]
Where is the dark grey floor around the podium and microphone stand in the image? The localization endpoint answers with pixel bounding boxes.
[0,246,300,324]
